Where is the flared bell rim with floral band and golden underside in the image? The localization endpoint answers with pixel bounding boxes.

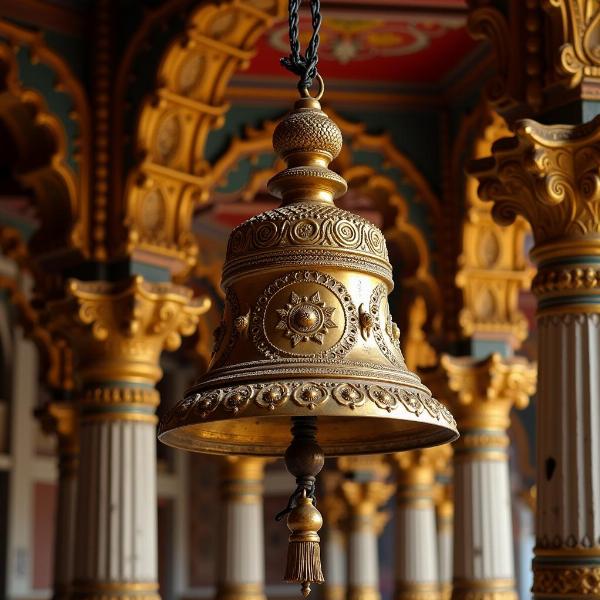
[159,378,458,456]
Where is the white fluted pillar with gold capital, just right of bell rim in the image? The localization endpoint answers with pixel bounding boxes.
[442,354,535,600]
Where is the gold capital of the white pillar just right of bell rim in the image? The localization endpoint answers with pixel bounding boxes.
[442,353,537,432]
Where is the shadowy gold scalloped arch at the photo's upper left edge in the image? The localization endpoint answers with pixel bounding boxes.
[0,20,90,263]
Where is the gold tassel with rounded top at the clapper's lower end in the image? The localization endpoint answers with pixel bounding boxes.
[284,490,324,598]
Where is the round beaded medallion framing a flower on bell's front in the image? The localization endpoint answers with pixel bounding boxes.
[250,271,358,362]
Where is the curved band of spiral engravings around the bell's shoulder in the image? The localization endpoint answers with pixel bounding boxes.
[227,202,388,262]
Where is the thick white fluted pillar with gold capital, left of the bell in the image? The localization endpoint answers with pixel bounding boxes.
[48,277,208,600]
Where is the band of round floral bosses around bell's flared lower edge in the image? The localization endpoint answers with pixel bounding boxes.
[160,381,456,433]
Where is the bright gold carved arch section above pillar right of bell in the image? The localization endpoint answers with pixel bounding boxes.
[453,105,534,348]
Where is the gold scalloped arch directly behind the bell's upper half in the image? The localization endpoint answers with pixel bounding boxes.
[194,108,441,368]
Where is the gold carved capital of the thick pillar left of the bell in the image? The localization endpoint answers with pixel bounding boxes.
[48,276,210,384]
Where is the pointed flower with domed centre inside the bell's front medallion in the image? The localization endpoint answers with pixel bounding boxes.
[275,291,337,347]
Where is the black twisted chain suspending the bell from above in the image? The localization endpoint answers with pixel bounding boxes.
[281,0,321,93]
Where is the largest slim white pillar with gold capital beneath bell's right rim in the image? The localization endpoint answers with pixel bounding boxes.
[393,446,451,600]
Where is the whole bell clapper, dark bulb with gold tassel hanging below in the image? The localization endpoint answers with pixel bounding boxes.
[276,417,325,597]
